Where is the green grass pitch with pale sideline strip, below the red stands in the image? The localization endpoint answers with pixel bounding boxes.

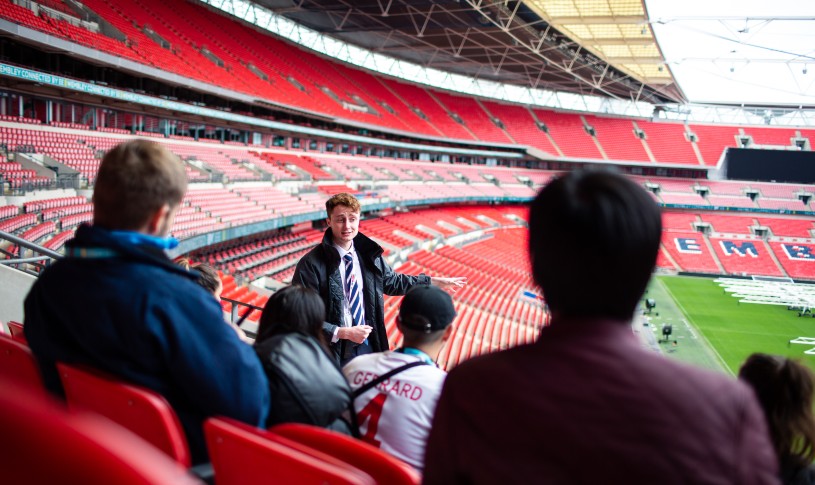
[642,276,815,374]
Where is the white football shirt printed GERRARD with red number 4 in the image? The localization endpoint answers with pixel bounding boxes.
[342,351,447,471]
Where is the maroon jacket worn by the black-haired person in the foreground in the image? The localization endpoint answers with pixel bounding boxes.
[424,321,778,485]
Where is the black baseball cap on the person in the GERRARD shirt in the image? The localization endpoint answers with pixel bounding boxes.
[399,285,456,333]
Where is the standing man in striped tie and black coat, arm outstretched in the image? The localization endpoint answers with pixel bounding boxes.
[292,193,466,365]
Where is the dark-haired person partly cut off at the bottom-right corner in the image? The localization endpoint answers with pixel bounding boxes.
[739,353,815,485]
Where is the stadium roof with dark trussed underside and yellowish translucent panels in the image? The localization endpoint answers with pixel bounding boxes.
[252,0,686,105]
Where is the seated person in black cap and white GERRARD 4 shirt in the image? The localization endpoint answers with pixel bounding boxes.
[342,286,456,470]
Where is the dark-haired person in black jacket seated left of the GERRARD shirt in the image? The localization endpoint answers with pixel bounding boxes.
[255,285,351,434]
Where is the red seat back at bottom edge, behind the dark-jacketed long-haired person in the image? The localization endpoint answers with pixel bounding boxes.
[204,418,376,485]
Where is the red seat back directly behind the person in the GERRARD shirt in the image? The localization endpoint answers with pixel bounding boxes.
[270,423,422,485]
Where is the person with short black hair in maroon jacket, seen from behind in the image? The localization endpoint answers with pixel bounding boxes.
[424,171,778,484]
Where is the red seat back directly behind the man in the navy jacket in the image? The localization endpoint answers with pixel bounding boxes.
[57,362,190,467]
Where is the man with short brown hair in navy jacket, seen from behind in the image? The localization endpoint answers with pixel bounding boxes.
[25,140,269,464]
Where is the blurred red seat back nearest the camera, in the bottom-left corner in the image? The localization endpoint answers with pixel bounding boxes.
[0,376,201,485]
